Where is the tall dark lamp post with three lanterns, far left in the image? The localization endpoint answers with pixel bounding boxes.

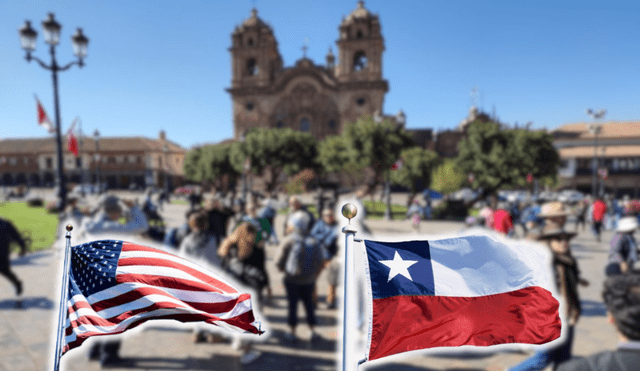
[18,13,89,210]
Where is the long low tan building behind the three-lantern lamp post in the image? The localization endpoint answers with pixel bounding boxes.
[0,131,185,189]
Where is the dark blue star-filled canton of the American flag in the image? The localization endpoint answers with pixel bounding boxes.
[69,240,122,297]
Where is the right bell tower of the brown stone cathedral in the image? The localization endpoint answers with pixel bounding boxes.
[336,1,384,82]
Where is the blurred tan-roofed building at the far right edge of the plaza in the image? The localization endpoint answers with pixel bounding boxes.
[552,121,640,197]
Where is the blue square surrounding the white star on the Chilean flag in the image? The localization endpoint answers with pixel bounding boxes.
[364,240,435,299]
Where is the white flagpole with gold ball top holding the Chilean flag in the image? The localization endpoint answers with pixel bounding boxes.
[340,203,358,371]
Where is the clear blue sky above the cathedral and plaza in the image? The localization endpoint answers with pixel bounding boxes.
[0,0,640,148]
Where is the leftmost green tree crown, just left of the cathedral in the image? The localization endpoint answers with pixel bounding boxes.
[184,143,240,187]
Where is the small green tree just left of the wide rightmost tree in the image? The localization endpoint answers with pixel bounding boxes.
[391,147,440,204]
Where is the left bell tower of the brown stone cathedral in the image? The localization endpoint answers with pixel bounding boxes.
[229,8,282,88]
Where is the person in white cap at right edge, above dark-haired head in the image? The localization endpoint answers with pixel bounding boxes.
[605,216,638,276]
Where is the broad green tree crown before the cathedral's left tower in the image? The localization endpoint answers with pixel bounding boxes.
[230,128,318,190]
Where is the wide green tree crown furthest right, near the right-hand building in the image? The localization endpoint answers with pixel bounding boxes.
[456,121,560,196]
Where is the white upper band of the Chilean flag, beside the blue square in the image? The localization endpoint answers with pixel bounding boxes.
[428,236,553,297]
